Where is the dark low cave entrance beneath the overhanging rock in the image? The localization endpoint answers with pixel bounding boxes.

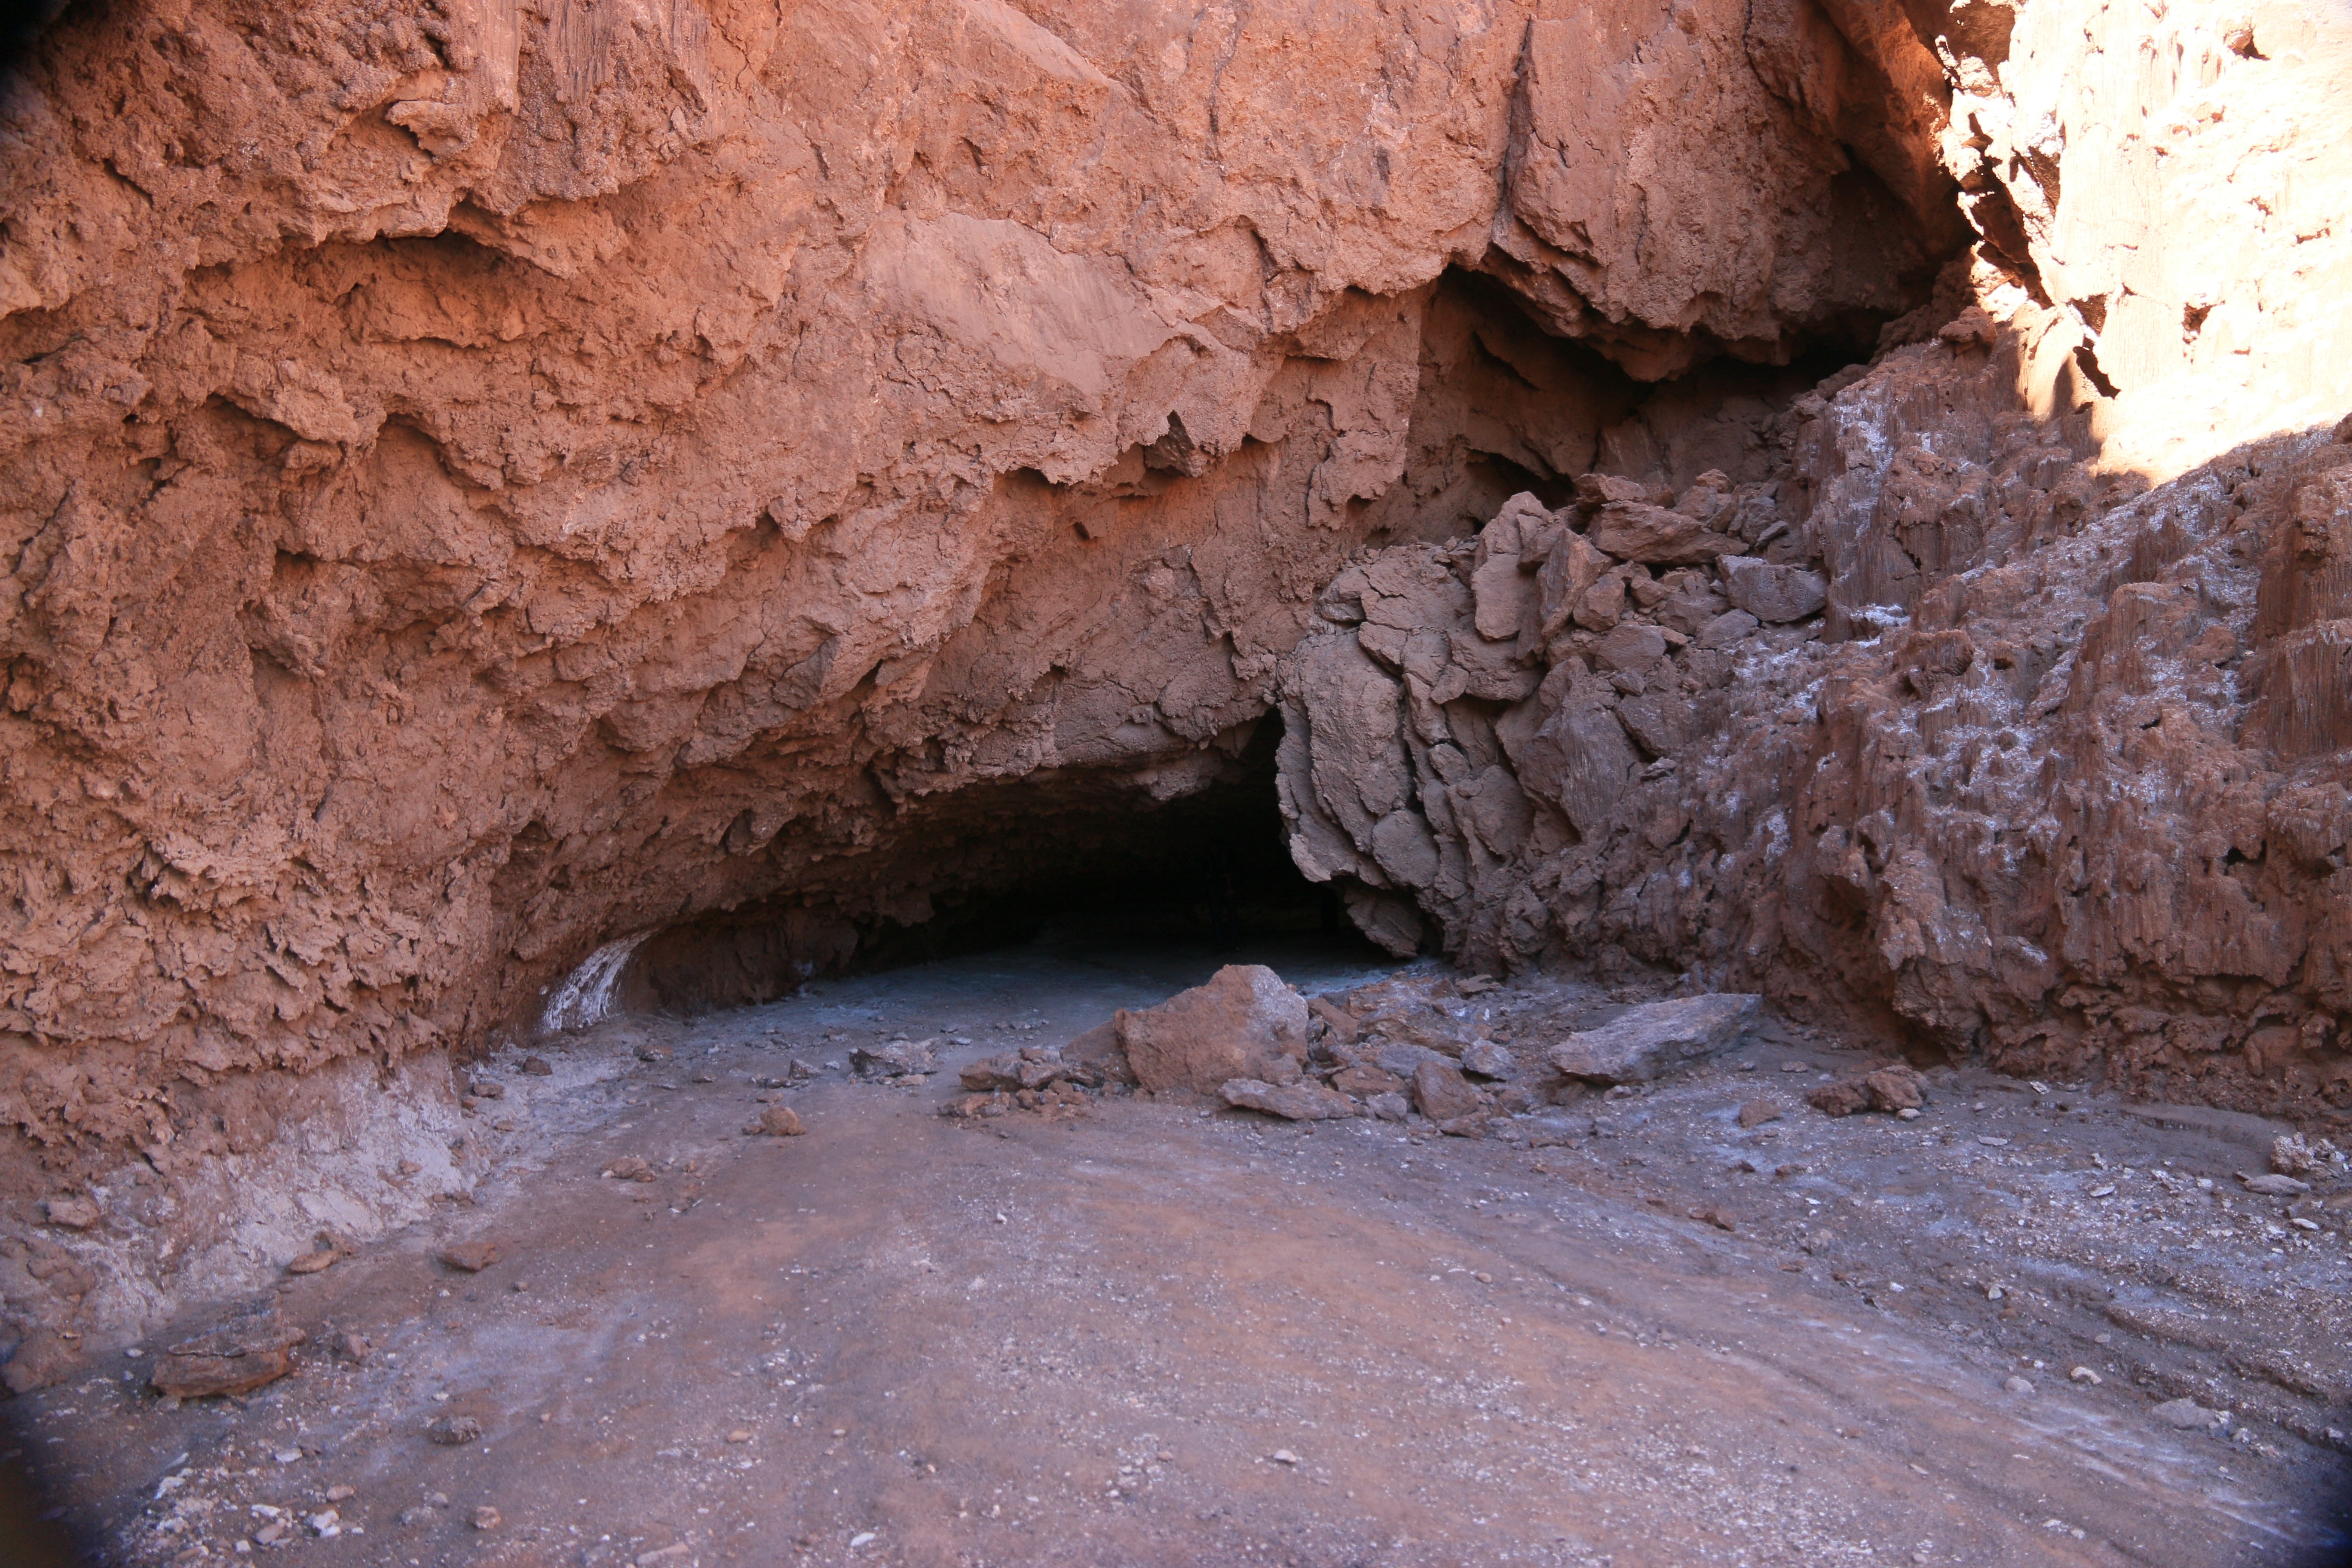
[614,715,1395,1016]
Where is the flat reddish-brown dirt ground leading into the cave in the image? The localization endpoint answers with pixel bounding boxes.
[0,940,2352,1568]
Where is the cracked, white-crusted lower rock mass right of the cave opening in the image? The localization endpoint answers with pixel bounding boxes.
[1284,289,2352,1105]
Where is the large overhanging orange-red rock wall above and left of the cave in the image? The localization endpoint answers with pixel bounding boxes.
[0,0,1957,1175]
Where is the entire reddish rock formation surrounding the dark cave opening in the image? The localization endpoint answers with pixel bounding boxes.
[0,0,2352,1363]
